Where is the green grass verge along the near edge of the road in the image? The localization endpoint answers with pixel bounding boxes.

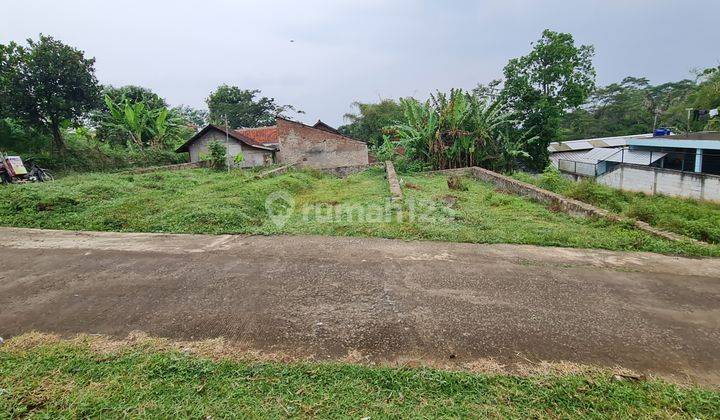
[0,340,720,419]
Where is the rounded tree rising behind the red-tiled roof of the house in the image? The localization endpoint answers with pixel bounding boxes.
[206,85,303,128]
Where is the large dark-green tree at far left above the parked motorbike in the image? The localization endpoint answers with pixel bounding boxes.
[0,35,100,150]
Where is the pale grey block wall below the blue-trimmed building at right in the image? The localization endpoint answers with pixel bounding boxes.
[597,164,720,202]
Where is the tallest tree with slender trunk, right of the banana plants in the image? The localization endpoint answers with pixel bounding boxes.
[501,29,595,170]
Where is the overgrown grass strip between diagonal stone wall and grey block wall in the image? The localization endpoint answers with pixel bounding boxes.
[513,172,720,244]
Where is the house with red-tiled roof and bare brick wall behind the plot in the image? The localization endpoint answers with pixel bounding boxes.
[176,117,368,168]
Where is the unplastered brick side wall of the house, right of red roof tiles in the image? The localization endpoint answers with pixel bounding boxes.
[277,119,368,168]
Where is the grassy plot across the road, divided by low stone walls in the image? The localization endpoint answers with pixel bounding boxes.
[0,169,720,256]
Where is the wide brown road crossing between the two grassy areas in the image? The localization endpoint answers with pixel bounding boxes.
[0,228,720,384]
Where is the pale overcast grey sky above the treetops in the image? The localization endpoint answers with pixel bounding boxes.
[0,0,720,125]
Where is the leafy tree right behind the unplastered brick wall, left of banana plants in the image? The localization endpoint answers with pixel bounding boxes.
[338,99,403,146]
